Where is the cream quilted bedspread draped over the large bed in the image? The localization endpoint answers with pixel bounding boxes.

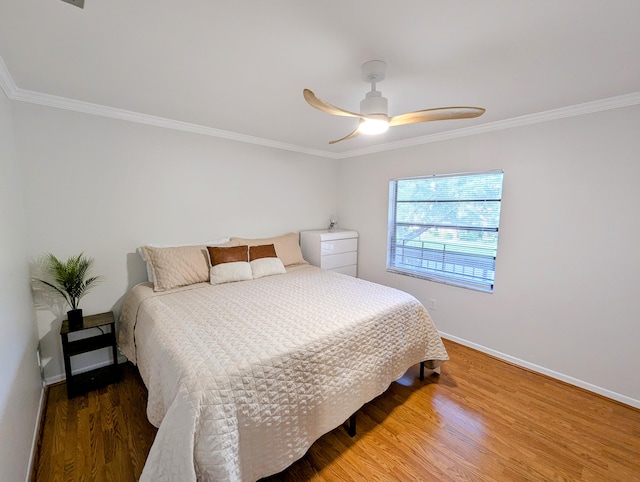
[119,266,448,481]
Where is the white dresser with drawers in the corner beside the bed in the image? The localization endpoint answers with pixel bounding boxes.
[300,229,358,277]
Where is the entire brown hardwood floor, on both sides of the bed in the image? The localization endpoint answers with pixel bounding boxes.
[35,340,640,482]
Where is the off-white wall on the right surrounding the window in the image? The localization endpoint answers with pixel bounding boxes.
[339,106,640,407]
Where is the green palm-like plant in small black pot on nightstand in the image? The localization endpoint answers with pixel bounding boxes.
[36,253,102,327]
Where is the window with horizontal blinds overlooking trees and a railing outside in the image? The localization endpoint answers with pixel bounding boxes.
[387,170,503,292]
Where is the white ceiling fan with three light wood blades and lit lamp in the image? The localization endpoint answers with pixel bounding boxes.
[302,60,485,144]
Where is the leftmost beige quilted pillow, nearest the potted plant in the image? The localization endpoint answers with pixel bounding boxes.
[142,246,209,291]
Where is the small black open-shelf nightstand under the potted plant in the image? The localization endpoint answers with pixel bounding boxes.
[60,311,120,398]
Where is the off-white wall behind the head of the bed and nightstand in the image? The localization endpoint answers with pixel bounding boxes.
[14,103,337,381]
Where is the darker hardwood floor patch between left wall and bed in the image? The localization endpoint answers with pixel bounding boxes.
[33,363,157,482]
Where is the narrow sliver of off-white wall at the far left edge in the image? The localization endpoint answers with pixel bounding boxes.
[0,89,43,481]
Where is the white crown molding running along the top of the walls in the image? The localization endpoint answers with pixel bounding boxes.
[0,56,640,159]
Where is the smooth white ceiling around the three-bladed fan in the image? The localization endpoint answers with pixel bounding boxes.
[0,0,640,157]
